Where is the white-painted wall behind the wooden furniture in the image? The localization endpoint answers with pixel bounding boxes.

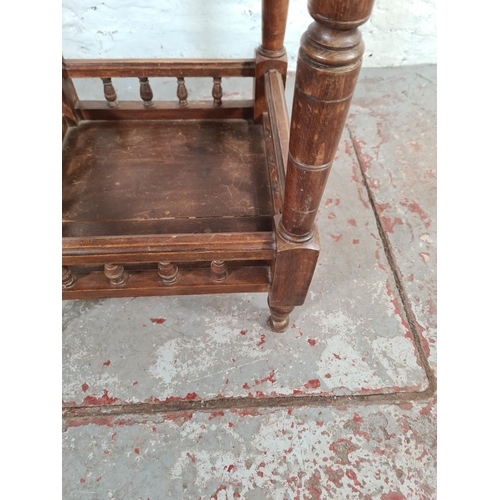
[62,0,437,69]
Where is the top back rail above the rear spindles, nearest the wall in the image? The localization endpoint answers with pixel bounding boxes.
[62,59,255,78]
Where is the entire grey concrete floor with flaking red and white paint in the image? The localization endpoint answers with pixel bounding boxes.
[63,66,436,500]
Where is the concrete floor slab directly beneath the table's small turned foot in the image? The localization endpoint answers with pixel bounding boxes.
[63,120,427,405]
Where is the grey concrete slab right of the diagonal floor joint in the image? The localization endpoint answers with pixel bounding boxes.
[347,65,437,369]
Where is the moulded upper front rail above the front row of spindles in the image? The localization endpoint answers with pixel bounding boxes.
[62,232,276,266]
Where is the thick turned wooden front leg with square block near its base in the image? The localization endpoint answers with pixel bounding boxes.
[269,0,373,332]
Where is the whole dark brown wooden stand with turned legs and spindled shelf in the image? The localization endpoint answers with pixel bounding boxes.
[62,0,373,332]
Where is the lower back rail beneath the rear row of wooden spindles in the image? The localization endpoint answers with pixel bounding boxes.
[77,100,253,120]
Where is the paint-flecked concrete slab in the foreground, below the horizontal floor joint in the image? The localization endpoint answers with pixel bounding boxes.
[63,402,436,500]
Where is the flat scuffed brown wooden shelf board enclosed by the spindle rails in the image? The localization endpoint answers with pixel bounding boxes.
[63,120,273,221]
